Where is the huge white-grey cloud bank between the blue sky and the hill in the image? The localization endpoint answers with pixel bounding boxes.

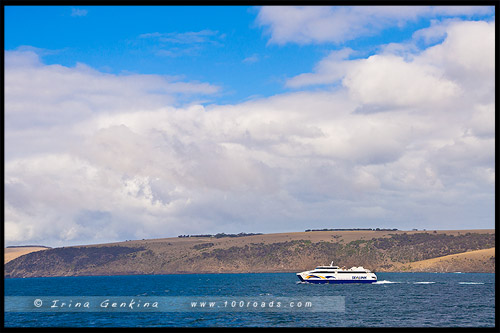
[5,15,495,246]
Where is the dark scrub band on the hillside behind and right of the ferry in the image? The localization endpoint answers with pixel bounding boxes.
[192,233,495,266]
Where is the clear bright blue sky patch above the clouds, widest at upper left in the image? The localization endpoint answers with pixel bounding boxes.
[5,6,491,103]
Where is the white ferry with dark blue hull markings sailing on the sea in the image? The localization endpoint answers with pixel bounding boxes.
[297,261,377,283]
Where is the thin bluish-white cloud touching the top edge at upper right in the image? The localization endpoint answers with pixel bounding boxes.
[257,6,494,45]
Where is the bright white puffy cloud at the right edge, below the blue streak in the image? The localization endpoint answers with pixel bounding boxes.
[287,20,495,112]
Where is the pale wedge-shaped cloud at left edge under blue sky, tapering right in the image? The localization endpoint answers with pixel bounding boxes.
[5,51,219,128]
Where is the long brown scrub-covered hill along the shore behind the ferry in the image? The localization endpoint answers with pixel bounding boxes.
[4,230,495,277]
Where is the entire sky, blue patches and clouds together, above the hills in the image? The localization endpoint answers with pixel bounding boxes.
[4,6,495,246]
